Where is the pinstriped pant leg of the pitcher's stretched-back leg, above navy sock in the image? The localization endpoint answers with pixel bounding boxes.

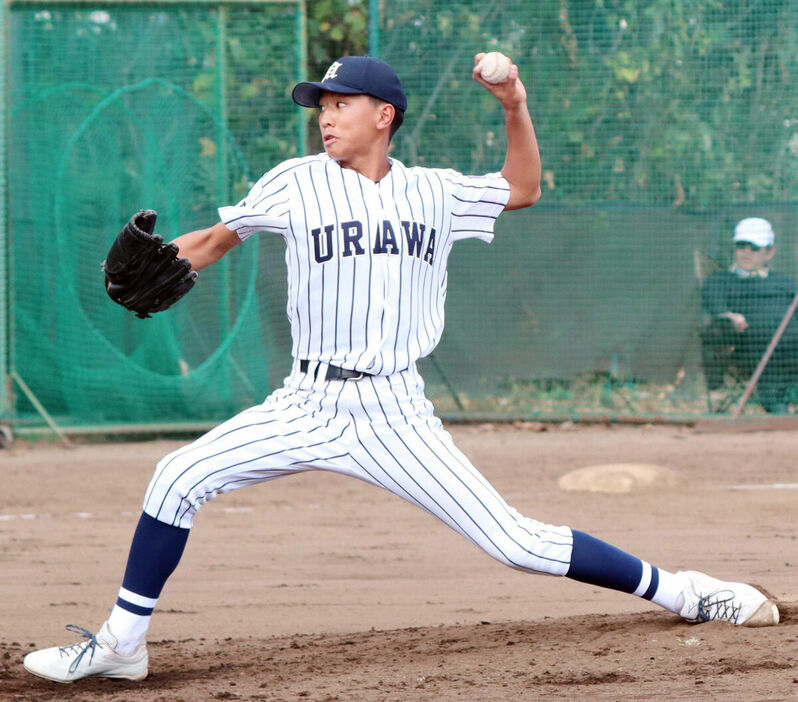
[350,377,573,575]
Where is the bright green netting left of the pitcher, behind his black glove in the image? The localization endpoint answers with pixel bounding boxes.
[9,3,302,424]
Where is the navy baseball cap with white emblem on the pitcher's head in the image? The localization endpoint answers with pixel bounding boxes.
[291,56,407,112]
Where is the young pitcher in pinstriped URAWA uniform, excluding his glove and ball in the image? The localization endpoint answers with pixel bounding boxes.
[25,54,778,682]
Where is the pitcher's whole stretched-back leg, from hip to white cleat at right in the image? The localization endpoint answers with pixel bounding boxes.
[352,379,779,626]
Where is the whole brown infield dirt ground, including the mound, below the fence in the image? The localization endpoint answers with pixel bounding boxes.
[0,424,798,702]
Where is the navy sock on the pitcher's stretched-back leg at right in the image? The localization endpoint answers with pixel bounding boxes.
[566,530,657,599]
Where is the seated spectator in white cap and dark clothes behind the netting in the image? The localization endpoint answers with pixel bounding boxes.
[701,217,798,414]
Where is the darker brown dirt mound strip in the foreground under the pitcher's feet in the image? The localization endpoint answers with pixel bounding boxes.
[0,605,798,702]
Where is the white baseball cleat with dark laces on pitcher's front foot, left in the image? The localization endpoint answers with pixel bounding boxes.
[22,622,148,683]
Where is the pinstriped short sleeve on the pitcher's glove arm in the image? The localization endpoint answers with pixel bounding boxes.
[219,159,298,241]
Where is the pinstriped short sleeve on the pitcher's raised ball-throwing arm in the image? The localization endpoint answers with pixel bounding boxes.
[443,170,510,242]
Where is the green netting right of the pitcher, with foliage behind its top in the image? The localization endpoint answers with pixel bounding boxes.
[382,0,798,417]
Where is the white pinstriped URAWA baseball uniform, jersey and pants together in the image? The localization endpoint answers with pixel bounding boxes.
[144,154,572,575]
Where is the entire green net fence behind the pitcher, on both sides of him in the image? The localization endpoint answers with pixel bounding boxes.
[0,0,798,430]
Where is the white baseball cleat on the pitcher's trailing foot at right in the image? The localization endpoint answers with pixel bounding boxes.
[679,570,779,626]
